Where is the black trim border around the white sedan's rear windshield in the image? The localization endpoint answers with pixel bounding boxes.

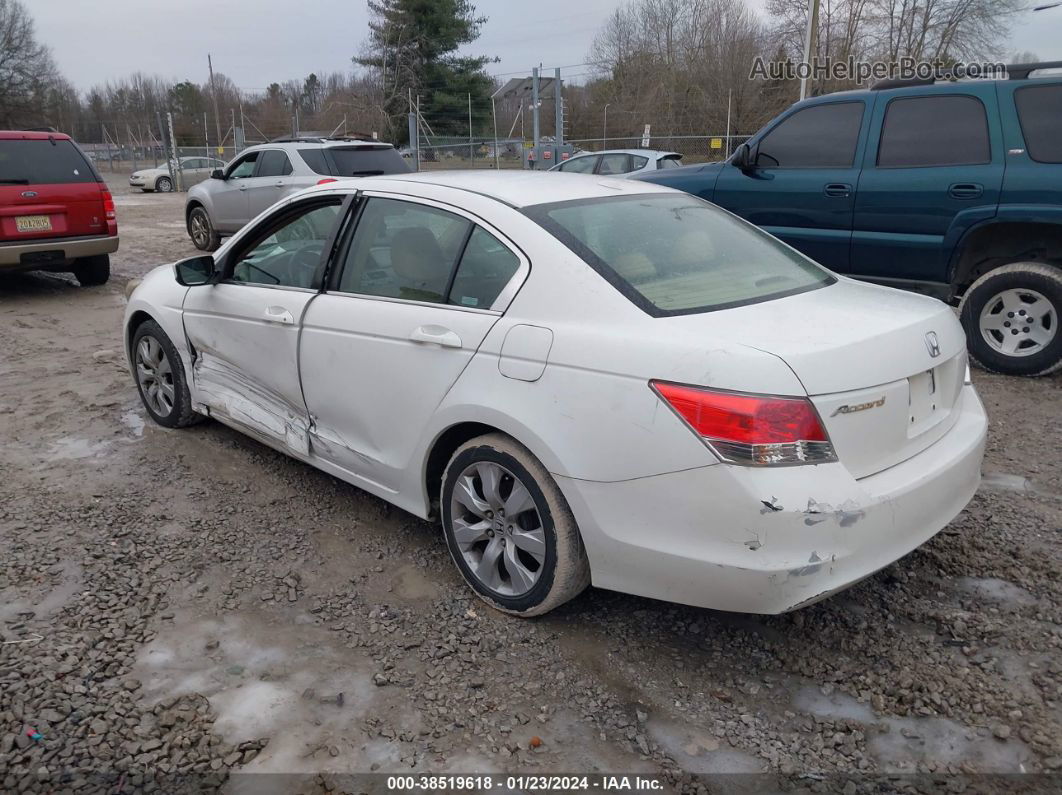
[520,193,837,317]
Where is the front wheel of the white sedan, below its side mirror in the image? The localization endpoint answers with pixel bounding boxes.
[130,321,202,428]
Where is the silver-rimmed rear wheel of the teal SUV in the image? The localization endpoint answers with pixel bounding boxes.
[959,262,1062,376]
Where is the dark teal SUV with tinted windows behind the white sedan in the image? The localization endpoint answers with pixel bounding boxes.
[639,62,1062,376]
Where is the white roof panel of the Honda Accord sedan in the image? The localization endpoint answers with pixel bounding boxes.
[321,169,676,207]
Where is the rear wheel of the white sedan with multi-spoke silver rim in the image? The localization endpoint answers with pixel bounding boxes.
[440,433,590,617]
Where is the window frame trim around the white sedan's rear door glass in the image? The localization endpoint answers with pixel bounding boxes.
[322,190,531,316]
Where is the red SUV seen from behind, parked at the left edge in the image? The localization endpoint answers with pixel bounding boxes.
[0,131,118,286]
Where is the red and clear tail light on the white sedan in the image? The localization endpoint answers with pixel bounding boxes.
[650,381,837,466]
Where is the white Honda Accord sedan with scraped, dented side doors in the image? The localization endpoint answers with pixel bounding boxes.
[125,172,987,616]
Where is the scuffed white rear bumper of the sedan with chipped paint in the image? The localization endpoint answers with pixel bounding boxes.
[558,385,988,613]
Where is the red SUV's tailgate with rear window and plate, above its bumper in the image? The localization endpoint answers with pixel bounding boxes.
[0,134,109,243]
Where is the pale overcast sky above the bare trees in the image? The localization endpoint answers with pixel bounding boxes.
[23,0,1062,91]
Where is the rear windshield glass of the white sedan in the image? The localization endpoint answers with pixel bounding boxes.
[524,195,836,317]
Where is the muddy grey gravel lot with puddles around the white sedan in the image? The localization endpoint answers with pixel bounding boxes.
[0,179,1062,793]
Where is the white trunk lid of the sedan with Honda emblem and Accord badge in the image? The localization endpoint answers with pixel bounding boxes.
[667,279,966,478]
